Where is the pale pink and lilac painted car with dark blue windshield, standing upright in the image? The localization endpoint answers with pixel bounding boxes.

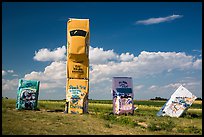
[112,77,134,115]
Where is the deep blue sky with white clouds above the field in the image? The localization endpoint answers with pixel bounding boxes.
[2,2,202,100]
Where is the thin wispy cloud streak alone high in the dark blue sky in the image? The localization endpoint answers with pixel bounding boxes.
[136,15,183,25]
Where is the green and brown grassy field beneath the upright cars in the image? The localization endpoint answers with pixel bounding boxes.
[2,99,202,135]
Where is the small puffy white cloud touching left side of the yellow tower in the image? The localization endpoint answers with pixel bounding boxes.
[33,46,66,61]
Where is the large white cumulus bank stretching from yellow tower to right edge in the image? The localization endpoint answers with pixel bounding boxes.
[90,51,201,83]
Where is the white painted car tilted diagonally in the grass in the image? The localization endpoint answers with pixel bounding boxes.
[157,85,197,117]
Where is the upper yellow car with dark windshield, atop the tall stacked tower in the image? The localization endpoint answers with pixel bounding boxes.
[67,19,90,79]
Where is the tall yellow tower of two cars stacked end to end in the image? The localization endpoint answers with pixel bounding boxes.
[65,18,90,114]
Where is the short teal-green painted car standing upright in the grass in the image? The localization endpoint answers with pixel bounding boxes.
[16,79,40,110]
